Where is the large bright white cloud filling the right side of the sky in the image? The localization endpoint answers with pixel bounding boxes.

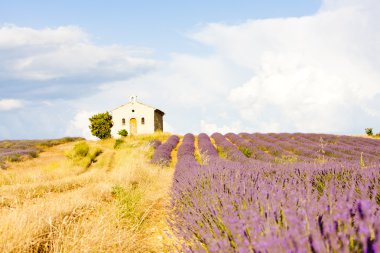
[193,0,380,133]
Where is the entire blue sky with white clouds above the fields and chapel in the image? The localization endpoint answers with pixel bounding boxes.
[0,0,380,139]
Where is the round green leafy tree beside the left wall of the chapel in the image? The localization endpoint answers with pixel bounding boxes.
[89,112,113,140]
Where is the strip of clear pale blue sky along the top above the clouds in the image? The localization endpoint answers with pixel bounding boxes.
[0,0,320,58]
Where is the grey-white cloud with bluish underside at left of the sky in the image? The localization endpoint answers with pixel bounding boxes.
[0,25,157,98]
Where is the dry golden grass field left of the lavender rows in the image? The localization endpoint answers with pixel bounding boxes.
[0,133,174,252]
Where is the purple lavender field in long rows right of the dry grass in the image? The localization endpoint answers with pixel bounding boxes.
[153,133,380,253]
